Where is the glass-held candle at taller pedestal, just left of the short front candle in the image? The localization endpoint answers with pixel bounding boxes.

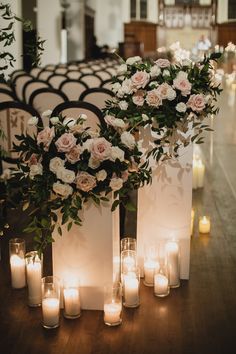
[143,245,159,286]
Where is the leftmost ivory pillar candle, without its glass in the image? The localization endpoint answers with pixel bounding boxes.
[10,254,26,289]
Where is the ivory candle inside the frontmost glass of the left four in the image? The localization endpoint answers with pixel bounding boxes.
[42,297,60,328]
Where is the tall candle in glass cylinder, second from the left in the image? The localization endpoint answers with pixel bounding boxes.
[25,251,43,306]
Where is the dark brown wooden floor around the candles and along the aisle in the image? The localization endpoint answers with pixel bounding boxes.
[0,86,236,354]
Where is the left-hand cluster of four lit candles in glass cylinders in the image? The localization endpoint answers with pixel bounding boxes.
[9,238,81,328]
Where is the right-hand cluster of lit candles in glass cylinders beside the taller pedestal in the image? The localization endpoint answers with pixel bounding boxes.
[104,237,180,326]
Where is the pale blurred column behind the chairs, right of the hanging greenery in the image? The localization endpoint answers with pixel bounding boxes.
[37,0,61,66]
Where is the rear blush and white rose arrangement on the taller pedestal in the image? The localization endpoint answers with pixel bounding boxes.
[105,53,221,161]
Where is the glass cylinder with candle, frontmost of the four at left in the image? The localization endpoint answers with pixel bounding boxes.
[42,276,60,329]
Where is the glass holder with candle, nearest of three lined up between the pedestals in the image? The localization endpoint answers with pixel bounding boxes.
[122,268,140,307]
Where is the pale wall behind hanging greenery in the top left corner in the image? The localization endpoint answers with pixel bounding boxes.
[0,0,23,77]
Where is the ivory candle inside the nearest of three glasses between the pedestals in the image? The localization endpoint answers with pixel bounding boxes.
[124,274,139,307]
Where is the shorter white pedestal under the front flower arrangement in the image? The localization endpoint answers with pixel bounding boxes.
[52,202,120,310]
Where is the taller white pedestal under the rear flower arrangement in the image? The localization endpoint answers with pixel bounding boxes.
[137,128,193,279]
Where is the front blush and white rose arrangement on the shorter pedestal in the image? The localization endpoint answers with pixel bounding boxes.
[8,111,150,251]
